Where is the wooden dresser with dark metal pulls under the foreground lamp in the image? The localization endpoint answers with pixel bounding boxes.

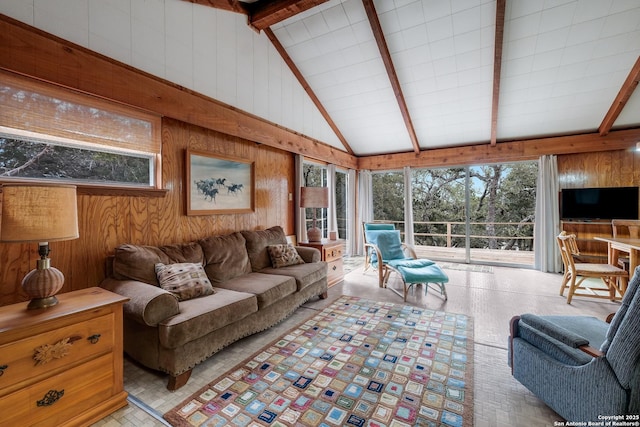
[0,288,127,427]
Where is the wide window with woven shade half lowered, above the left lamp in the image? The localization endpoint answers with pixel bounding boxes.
[0,71,161,188]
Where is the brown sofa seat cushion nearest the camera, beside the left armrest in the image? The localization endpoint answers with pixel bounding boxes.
[158,287,258,348]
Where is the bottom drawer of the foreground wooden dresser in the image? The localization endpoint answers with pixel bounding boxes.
[0,354,115,427]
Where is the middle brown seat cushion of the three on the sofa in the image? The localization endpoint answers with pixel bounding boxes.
[216,270,297,310]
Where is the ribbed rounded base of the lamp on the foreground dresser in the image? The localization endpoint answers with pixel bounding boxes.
[22,264,64,310]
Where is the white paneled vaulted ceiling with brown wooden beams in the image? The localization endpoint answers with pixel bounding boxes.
[185,0,640,156]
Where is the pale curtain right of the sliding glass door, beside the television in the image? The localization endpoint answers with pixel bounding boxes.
[533,155,562,273]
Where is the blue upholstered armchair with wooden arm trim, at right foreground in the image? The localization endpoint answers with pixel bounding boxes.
[509,267,640,421]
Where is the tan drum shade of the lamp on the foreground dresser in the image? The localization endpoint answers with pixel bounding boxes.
[0,183,79,242]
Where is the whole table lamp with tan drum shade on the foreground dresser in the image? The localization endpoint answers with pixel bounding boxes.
[0,183,78,309]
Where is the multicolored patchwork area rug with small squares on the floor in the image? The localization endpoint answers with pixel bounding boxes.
[164,296,473,427]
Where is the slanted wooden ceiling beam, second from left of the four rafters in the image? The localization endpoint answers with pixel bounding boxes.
[362,0,420,153]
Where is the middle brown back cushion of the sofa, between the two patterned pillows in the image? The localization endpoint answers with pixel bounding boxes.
[199,232,251,283]
